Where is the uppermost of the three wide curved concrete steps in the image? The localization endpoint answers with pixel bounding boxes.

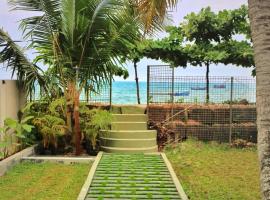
[100,130,157,139]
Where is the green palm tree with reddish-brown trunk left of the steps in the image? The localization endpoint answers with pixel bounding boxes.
[9,0,139,154]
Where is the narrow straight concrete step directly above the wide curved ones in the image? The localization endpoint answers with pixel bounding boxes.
[111,122,147,130]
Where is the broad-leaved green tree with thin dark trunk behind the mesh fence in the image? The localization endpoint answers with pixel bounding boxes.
[138,6,254,102]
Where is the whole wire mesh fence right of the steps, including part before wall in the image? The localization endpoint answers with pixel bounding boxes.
[147,66,257,142]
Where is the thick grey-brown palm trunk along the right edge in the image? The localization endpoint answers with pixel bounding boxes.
[248,0,270,200]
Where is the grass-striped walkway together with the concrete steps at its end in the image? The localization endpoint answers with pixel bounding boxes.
[78,106,187,200]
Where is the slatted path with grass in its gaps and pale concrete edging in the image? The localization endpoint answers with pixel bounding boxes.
[78,153,187,200]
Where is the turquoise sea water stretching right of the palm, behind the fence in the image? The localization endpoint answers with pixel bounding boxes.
[98,81,256,104]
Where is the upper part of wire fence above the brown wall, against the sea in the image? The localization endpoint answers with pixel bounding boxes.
[147,65,256,104]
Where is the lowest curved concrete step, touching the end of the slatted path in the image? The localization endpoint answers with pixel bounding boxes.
[100,145,158,154]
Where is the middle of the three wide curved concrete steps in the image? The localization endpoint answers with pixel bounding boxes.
[99,137,157,148]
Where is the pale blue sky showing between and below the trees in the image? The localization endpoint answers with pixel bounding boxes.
[0,0,252,81]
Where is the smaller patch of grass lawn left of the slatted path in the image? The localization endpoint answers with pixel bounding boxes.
[0,162,90,200]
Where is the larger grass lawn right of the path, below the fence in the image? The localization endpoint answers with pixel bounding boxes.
[166,141,260,200]
